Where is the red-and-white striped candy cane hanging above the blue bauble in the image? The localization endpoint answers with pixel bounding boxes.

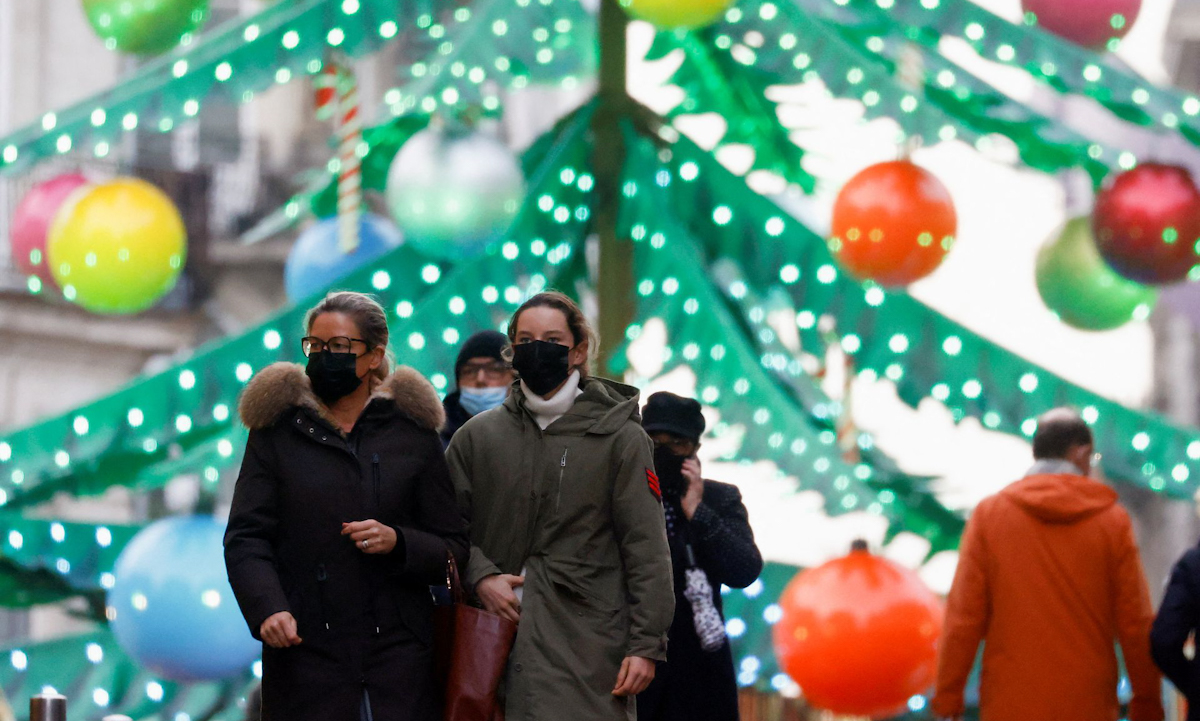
[314,56,362,253]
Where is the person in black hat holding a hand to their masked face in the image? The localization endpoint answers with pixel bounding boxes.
[637,392,762,721]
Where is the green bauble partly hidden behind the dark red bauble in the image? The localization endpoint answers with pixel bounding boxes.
[1037,217,1158,330]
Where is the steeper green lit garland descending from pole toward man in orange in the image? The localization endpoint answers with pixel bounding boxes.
[613,131,964,554]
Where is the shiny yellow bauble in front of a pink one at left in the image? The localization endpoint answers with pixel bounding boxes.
[46,178,187,313]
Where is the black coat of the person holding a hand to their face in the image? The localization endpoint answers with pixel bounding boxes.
[637,481,762,721]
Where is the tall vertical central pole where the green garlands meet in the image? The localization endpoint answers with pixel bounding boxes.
[592,0,634,373]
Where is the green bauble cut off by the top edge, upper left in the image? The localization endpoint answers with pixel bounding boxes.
[83,0,209,55]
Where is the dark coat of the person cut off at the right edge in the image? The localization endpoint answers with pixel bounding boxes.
[1150,548,1200,721]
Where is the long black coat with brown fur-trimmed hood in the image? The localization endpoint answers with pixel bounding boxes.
[224,363,468,721]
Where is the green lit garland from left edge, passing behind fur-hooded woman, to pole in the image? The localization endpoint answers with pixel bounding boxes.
[0,105,592,507]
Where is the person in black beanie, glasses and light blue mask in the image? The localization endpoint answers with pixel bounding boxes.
[442,330,514,445]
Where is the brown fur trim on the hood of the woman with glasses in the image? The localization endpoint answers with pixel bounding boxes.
[238,362,446,431]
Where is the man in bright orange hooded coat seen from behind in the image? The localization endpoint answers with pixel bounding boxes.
[932,409,1163,721]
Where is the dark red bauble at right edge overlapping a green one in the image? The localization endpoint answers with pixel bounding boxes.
[1092,163,1200,284]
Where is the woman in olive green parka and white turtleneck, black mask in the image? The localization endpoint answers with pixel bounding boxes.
[448,293,674,721]
